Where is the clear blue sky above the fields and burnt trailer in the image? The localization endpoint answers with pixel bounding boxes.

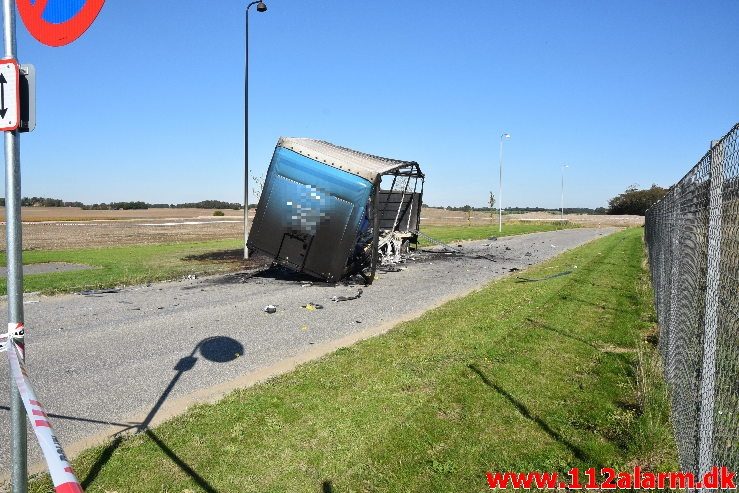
[3,0,739,207]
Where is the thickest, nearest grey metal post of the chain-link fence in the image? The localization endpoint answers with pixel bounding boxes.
[698,136,724,478]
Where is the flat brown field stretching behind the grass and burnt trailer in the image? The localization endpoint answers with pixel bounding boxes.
[0,207,644,250]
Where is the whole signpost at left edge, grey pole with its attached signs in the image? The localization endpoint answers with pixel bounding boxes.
[0,0,105,493]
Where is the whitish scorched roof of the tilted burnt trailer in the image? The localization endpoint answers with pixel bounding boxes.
[277,137,423,181]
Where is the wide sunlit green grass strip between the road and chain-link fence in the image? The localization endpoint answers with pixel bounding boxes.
[30,229,677,492]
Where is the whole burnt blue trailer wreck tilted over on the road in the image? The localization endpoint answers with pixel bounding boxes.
[248,137,424,282]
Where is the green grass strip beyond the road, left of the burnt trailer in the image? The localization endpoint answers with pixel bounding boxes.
[0,240,243,294]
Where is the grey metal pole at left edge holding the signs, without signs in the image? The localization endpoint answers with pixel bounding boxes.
[3,0,28,493]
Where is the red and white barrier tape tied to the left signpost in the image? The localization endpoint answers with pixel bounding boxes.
[5,324,83,493]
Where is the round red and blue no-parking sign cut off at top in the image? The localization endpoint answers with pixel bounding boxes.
[17,0,105,46]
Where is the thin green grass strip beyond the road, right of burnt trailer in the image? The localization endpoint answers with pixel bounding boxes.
[419,221,578,246]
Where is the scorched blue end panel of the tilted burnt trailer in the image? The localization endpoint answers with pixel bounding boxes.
[249,146,372,281]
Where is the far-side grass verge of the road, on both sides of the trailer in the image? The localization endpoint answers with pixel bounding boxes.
[0,223,572,295]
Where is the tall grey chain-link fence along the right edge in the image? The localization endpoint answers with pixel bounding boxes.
[645,124,739,480]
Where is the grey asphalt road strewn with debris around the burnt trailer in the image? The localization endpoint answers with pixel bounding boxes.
[0,228,615,479]
